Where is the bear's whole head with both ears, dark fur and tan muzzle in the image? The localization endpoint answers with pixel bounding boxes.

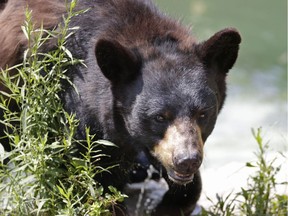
[95,29,240,185]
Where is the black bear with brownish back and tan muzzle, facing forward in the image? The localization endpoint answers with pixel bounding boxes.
[0,0,241,215]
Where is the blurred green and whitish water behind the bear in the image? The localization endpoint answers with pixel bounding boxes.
[155,0,288,208]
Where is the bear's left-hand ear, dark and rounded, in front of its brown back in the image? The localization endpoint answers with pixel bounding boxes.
[95,39,141,84]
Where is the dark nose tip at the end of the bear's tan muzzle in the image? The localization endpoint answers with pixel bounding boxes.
[173,153,202,174]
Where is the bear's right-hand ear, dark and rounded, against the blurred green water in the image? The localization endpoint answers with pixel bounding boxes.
[197,28,241,73]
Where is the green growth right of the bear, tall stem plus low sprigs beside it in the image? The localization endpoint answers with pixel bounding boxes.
[203,129,288,216]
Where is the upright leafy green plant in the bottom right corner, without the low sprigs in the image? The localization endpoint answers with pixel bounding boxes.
[240,129,288,215]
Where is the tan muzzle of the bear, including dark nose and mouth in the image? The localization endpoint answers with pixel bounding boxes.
[151,120,203,185]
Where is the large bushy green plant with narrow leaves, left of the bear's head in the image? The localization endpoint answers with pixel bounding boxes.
[0,1,125,215]
